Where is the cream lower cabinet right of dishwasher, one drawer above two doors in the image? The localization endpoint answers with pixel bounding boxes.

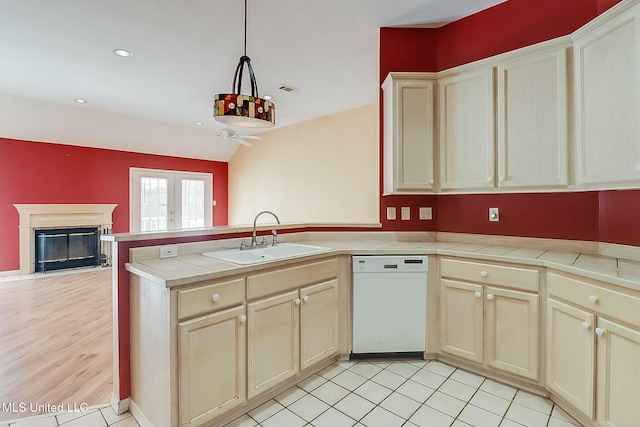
[440,259,540,382]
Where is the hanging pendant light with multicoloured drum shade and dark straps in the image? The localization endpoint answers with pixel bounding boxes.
[213,0,276,128]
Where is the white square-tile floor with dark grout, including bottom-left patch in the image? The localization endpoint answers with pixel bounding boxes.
[0,360,580,427]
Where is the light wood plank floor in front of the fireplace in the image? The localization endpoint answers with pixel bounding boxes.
[0,268,113,421]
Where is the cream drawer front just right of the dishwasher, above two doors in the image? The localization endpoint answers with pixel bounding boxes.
[440,259,539,292]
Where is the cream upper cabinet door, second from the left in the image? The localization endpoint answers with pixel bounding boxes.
[438,68,495,190]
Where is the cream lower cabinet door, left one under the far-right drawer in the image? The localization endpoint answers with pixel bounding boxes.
[546,299,595,419]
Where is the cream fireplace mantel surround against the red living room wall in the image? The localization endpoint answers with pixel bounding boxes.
[13,204,118,274]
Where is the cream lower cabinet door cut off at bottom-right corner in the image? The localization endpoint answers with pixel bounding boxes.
[596,318,640,427]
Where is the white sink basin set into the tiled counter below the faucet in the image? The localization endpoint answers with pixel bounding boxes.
[202,243,331,265]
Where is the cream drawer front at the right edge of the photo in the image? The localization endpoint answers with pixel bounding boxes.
[547,272,640,327]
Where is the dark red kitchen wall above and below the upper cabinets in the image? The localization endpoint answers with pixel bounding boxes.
[380,0,640,246]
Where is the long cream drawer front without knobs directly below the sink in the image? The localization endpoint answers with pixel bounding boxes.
[247,258,338,300]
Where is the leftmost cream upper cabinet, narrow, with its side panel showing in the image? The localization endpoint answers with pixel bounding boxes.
[382,73,435,194]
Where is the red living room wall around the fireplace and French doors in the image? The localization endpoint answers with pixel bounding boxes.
[0,138,228,271]
